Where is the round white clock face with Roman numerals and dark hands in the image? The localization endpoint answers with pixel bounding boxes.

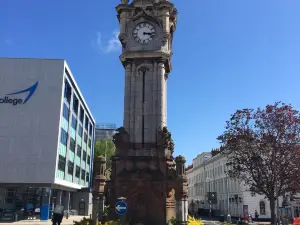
[132,22,155,44]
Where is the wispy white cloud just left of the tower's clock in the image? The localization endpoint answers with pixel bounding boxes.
[92,31,122,53]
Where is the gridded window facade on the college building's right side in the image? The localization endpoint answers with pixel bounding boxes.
[56,79,94,187]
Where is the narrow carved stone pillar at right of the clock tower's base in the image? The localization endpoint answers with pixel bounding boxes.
[175,156,188,225]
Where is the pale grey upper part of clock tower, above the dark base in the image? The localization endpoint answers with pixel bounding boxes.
[117,0,177,141]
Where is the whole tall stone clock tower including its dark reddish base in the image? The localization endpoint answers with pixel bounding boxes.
[105,0,187,225]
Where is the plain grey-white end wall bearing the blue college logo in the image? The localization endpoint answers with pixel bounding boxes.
[0,58,64,183]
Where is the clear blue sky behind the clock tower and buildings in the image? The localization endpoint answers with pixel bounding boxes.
[0,0,300,162]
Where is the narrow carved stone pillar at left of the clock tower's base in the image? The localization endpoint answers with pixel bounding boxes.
[92,156,106,225]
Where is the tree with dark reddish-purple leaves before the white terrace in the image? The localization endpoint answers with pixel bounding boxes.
[218,102,300,224]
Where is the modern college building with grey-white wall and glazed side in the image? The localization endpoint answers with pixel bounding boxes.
[0,58,95,220]
